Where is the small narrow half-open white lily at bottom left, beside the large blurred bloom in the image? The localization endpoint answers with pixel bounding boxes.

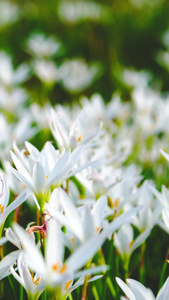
[10,252,45,300]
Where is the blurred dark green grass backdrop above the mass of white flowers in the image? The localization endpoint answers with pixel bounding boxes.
[0,0,169,103]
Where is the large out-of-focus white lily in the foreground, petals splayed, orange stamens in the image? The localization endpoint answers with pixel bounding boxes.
[13,219,107,290]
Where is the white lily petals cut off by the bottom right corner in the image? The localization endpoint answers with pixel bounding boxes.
[116,277,169,300]
